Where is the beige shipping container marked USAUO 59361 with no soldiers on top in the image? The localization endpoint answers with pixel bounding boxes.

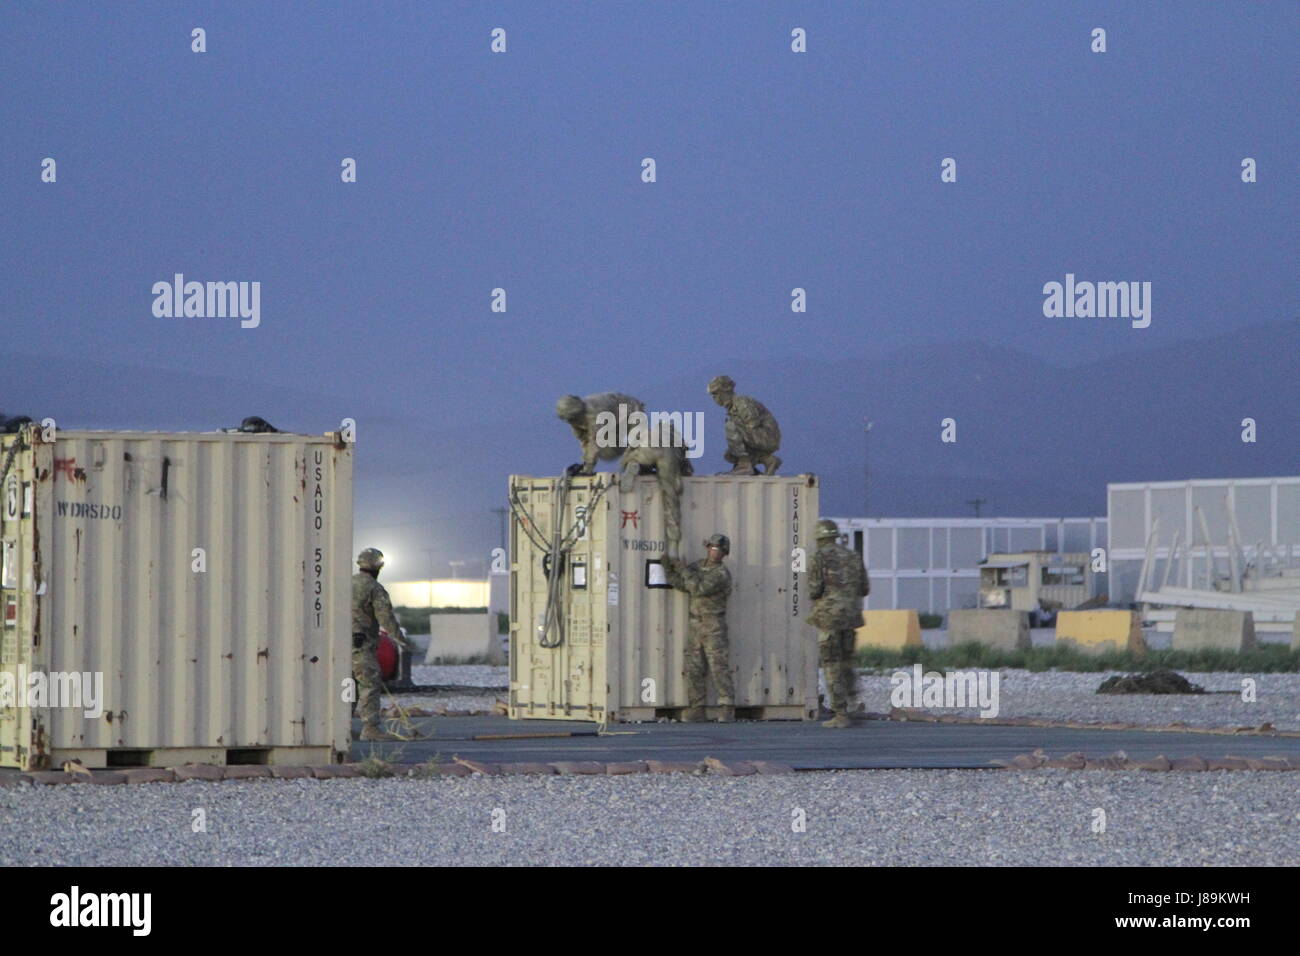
[0,425,352,769]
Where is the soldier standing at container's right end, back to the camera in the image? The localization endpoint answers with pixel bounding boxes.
[809,518,871,728]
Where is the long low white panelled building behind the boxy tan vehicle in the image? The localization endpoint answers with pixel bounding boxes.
[832,518,1106,614]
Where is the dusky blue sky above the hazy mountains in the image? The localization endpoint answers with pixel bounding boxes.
[0,0,1300,574]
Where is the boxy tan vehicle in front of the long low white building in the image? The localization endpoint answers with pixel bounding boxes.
[979,551,1105,627]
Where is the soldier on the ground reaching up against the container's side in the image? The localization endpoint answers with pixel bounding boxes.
[663,535,736,723]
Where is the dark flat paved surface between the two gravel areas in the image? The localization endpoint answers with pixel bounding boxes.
[352,717,1300,770]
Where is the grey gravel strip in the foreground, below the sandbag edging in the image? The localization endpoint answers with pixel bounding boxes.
[0,770,1300,866]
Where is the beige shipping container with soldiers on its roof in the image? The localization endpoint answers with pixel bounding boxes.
[510,473,818,723]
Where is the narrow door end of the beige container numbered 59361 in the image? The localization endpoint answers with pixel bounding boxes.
[0,436,42,769]
